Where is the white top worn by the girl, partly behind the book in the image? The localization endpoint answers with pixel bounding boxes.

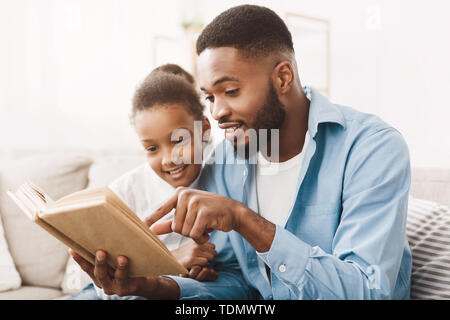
[94,163,194,300]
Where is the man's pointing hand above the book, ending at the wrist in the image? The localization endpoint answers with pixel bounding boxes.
[146,187,246,244]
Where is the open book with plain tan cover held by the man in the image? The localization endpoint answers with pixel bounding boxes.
[8,182,187,277]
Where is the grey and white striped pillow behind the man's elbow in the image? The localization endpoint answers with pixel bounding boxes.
[406,197,450,300]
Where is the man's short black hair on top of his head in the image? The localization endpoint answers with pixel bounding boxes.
[197,5,294,57]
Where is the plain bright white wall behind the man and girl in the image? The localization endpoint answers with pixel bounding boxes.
[0,0,450,167]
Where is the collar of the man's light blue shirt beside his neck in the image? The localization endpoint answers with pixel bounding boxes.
[303,87,345,138]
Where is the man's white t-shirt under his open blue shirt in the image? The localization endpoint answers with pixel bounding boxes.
[256,132,309,281]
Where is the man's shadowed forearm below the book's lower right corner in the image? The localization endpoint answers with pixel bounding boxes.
[136,277,180,300]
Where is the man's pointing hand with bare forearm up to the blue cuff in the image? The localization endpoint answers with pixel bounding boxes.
[146,187,276,252]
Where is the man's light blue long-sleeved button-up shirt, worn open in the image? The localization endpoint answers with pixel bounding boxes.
[168,88,412,299]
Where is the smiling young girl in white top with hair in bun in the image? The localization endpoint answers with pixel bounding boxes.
[72,64,217,299]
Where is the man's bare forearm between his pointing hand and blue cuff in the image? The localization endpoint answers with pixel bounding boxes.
[235,206,276,252]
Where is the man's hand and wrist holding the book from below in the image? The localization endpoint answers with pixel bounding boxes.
[70,250,180,299]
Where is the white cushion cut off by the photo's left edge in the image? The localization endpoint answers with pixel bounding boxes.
[0,209,22,292]
